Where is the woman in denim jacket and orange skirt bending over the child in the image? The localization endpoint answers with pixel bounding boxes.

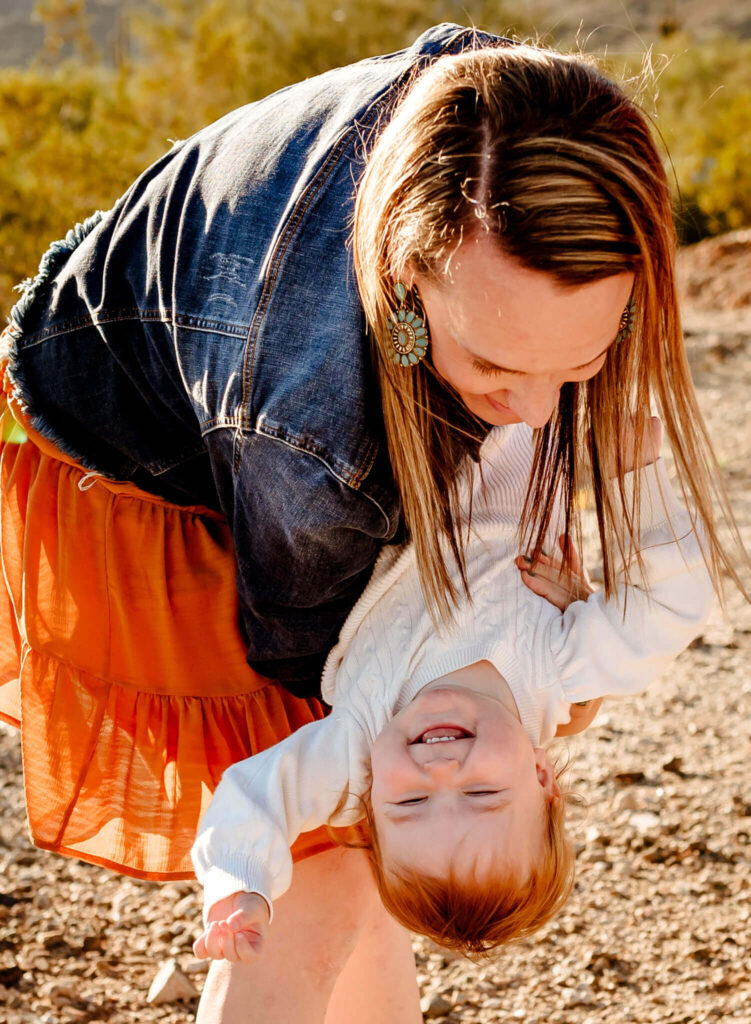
[2,26,734,1024]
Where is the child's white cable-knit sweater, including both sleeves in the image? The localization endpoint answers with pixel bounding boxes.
[193,424,712,912]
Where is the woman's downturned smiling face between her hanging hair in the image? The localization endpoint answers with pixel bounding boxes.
[408,233,633,427]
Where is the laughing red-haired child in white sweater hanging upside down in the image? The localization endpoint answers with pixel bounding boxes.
[193,420,712,959]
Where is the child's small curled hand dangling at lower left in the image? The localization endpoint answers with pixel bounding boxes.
[193,893,268,964]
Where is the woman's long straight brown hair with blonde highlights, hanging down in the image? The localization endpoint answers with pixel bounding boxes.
[353,39,743,621]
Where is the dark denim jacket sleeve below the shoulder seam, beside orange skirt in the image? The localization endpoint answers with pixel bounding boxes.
[201,429,399,695]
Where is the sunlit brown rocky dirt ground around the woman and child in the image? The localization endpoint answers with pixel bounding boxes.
[0,231,751,1024]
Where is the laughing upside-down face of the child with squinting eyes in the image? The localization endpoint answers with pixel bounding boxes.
[371,684,560,879]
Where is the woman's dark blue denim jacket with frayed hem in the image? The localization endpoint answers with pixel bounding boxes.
[8,25,499,694]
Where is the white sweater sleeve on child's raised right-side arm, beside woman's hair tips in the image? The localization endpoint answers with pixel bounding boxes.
[543,459,713,735]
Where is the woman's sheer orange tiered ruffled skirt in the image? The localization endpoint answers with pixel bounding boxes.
[0,368,334,880]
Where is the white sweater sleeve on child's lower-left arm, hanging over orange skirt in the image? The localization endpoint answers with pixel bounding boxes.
[191,712,367,921]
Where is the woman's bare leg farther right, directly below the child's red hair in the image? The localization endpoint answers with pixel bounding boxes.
[325,900,422,1024]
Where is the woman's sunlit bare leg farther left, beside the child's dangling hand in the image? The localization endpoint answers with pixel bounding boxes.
[197,850,419,1024]
